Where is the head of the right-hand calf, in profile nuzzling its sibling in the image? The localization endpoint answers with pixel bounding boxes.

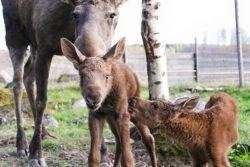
[129,96,199,127]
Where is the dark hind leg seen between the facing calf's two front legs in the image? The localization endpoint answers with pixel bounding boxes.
[108,118,122,167]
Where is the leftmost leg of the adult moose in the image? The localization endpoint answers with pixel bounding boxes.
[7,45,28,156]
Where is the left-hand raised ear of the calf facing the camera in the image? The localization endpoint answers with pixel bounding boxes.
[61,38,86,69]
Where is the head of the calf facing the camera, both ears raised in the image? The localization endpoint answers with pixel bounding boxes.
[61,38,125,111]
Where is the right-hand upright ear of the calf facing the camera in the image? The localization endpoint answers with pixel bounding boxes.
[103,38,125,63]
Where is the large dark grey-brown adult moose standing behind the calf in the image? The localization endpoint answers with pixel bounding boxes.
[1,0,125,167]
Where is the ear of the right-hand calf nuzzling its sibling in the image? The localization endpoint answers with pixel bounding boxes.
[174,96,200,110]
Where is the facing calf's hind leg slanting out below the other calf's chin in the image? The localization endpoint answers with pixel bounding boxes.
[134,121,157,167]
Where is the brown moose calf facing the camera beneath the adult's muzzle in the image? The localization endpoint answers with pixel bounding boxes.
[61,39,156,167]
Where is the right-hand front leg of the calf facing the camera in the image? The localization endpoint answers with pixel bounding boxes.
[117,96,135,167]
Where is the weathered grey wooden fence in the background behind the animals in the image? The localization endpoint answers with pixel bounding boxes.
[0,51,250,85]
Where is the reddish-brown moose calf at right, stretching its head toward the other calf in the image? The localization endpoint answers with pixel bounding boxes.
[129,93,238,167]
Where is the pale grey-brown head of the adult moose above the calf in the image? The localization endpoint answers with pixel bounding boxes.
[62,0,125,57]
